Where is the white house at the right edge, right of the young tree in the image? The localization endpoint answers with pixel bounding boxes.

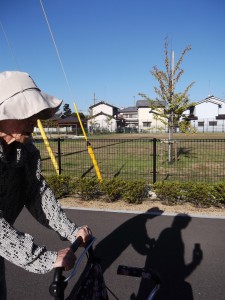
[183,96,225,132]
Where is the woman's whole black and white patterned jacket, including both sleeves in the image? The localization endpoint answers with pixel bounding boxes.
[0,141,78,273]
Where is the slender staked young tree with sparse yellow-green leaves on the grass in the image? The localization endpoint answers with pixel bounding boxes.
[139,38,194,162]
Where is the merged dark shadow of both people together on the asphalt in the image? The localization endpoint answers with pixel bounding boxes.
[95,208,203,300]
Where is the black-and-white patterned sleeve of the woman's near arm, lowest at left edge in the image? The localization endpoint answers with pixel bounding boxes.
[0,217,57,274]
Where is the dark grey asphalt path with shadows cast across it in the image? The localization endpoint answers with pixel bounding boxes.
[6,210,225,300]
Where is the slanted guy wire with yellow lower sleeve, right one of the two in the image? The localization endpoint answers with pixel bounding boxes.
[40,0,102,182]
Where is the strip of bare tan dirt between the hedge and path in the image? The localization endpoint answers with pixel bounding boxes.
[60,197,225,217]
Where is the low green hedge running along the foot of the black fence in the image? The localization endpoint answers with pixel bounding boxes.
[47,175,225,208]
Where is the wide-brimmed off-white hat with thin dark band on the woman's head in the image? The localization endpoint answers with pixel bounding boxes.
[0,71,62,120]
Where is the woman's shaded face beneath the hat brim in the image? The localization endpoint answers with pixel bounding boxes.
[0,116,38,144]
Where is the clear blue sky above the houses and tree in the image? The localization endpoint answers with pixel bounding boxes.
[0,0,225,113]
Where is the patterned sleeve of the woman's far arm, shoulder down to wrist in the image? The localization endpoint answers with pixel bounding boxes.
[26,142,79,243]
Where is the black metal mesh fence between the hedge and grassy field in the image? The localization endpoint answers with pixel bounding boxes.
[35,138,225,183]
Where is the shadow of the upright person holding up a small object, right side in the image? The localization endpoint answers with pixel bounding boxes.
[134,214,203,300]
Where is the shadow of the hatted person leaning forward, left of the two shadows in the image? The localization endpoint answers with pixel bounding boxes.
[94,207,162,273]
